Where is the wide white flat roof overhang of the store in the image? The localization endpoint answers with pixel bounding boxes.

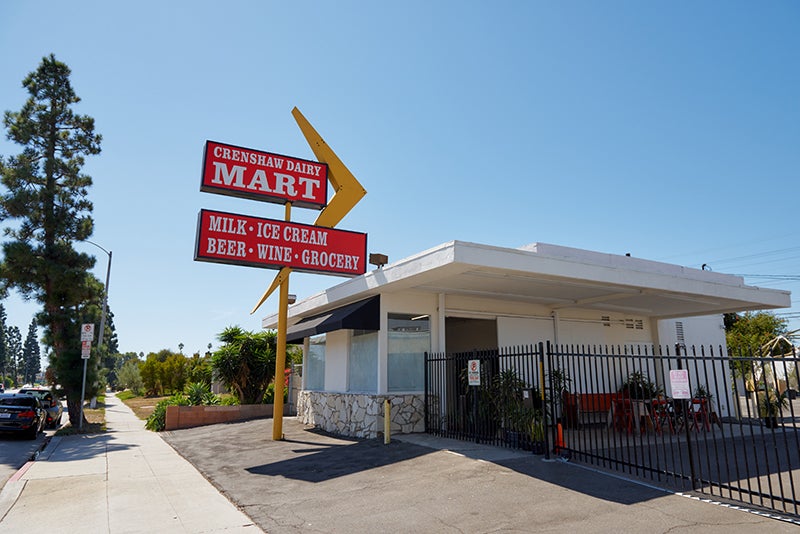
[262,241,791,328]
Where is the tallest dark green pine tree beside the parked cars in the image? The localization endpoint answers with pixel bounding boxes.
[0,54,102,426]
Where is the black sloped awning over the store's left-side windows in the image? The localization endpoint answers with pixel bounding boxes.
[286,295,381,343]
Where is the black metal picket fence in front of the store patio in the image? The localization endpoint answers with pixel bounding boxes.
[425,344,800,518]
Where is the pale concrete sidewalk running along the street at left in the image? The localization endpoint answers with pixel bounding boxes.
[0,394,262,534]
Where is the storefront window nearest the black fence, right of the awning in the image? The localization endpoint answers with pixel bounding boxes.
[387,313,431,391]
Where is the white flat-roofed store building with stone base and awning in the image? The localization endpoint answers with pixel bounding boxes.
[262,241,790,437]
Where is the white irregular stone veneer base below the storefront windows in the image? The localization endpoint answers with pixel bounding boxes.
[297,391,425,439]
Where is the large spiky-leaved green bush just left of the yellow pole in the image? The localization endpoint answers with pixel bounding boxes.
[211,326,276,404]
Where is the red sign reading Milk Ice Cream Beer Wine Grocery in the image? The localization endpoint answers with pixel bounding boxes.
[194,210,367,276]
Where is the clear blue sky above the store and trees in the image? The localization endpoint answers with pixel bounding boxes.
[0,0,800,353]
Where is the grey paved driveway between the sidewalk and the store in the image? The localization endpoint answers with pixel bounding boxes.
[161,418,798,534]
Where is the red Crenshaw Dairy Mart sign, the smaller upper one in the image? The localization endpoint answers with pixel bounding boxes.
[200,141,328,209]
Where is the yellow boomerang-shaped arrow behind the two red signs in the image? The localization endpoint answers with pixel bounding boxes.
[250,108,367,315]
